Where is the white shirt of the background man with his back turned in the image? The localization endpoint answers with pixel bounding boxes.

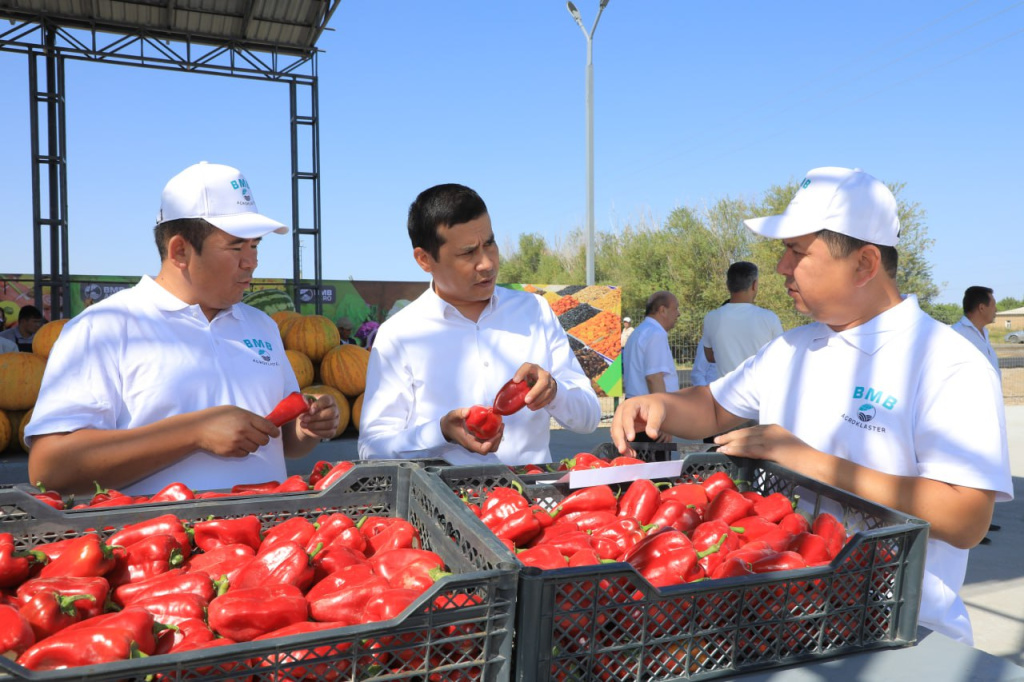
[700,303,782,377]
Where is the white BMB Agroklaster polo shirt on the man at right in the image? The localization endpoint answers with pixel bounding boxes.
[711,296,1013,643]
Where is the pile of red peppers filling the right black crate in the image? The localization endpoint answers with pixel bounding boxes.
[464,466,848,587]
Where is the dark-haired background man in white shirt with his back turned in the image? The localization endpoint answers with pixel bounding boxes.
[700,260,782,377]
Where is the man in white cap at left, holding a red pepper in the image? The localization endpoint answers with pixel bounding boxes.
[26,162,338,495]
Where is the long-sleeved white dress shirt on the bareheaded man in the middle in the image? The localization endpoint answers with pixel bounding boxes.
[358,286,601,466]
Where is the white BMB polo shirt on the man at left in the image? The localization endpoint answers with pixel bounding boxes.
[26,276,299,495]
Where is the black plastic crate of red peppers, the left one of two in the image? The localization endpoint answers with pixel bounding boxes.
[0,463,518,682]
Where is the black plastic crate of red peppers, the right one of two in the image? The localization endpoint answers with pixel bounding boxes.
[431,453,928,681]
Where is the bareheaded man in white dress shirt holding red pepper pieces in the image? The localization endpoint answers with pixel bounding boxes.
[359,184,601,465]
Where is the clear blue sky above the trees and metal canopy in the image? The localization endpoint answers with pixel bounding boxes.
[0,0,1024,302]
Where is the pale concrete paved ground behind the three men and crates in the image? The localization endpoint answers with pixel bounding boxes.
[0,406,1024,667]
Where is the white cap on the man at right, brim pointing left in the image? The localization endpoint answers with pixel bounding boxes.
[743,167,899,246]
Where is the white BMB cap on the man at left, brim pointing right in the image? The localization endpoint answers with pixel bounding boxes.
[157,161,288,240]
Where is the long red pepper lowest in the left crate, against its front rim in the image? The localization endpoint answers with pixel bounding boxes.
[16,627,138,671]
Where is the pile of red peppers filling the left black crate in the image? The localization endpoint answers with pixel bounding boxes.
[0,503,464,667]
